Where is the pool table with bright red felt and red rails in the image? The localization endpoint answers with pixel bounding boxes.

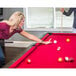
[9,33,76,68]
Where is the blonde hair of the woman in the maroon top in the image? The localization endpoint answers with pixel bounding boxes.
[9,11,24,27]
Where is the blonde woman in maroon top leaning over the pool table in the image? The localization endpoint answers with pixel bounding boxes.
[0,11,51,66]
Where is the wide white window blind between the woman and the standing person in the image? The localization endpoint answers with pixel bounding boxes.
[25,7,54,28]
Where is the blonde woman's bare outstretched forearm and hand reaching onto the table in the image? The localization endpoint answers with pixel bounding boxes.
[20,30,51,44]
